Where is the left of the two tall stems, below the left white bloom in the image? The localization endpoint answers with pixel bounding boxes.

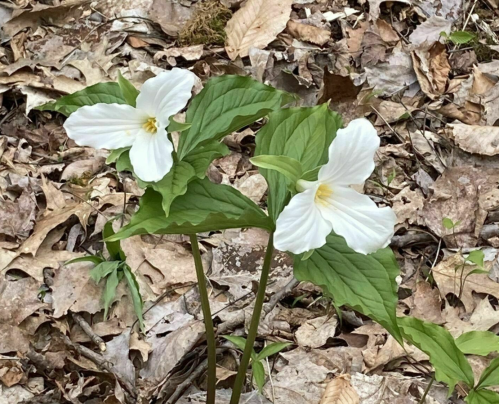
[189,234,217,404]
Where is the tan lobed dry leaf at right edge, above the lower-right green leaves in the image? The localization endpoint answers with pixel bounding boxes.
[433,254,499,313]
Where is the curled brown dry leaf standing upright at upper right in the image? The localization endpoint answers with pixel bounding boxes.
[411,42,450,100]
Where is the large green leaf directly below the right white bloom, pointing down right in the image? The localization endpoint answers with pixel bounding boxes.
[294,233,402,343]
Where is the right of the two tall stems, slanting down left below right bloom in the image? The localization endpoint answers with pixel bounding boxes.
[230,234,274,404]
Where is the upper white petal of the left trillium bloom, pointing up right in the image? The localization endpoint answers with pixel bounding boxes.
[137,68,197,127]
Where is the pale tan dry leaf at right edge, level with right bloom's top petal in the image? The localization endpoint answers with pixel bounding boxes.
[445,124,499,156]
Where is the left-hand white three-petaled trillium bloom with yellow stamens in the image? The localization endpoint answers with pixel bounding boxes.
[64,68,197,182]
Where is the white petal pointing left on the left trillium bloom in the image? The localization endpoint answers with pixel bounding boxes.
[64,104,147,149]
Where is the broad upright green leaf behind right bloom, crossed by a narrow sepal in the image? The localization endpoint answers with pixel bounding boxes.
[255,104,341,221]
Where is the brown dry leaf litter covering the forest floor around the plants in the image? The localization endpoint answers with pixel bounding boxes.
[0,0,499,404]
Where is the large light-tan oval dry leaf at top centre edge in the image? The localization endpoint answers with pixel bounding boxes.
[225,0,293,60]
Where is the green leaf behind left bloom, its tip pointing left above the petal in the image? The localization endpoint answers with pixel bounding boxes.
[35,82,127,116]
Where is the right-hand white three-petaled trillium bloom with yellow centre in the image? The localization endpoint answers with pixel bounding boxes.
[275,119,397,254]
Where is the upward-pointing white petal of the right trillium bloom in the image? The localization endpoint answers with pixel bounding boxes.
[319,118,379,185]
